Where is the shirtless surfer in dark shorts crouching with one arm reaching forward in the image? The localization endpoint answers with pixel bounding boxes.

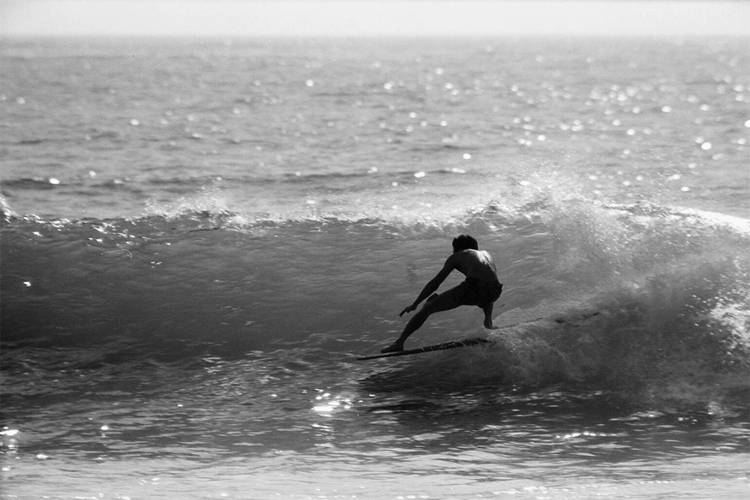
[381,234,503,353]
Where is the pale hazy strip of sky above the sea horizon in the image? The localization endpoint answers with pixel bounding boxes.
[0,0,750,38]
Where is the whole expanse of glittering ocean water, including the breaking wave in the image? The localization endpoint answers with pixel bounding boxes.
[0,38,750,499]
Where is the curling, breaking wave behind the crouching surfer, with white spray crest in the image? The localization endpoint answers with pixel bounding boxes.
[1,196,750,414]
